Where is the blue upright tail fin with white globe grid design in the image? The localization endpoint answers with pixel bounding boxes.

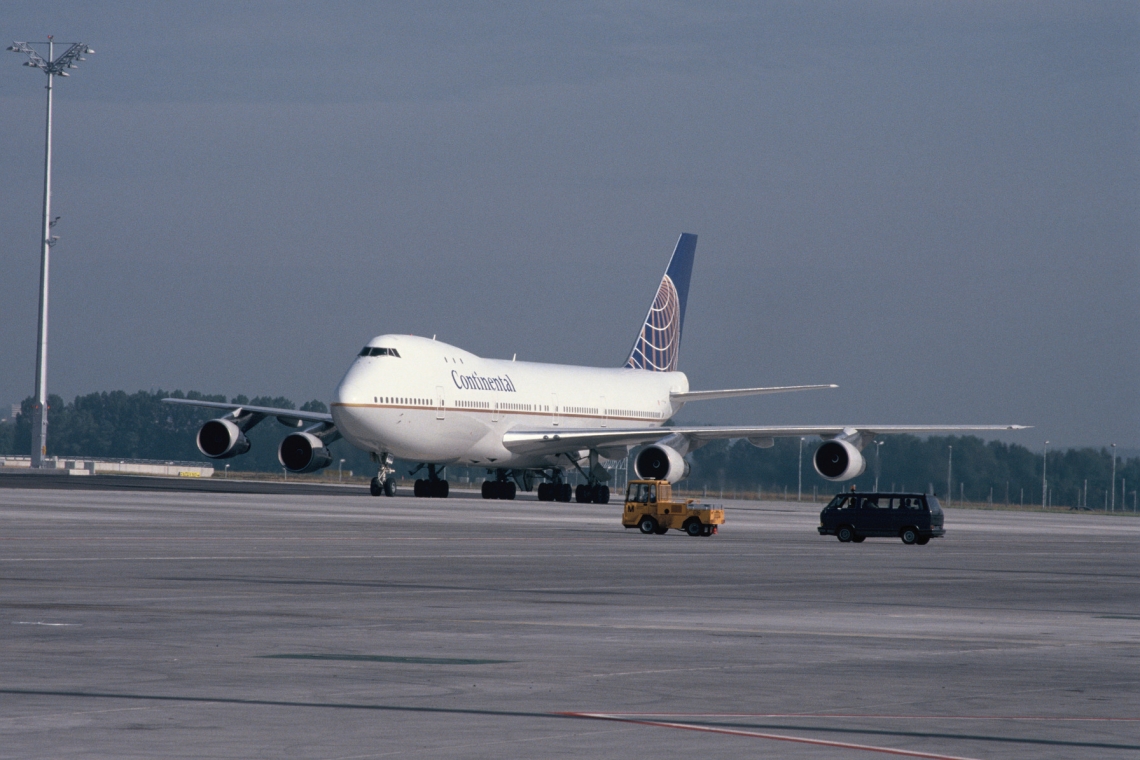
[626,232,697,373]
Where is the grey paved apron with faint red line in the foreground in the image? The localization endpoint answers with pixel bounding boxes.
[0,485,1140,759]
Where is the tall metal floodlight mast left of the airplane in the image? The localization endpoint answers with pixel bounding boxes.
[8,34,95,467]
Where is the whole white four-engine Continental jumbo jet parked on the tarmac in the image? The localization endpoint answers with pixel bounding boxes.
[165,234,1024,504]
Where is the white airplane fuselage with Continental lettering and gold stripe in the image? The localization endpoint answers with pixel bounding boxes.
[331,335,689,467]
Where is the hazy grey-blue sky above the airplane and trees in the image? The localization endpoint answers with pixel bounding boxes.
[0,2,1140,448]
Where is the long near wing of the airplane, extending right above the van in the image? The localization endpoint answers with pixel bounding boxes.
[503,425,1027,453]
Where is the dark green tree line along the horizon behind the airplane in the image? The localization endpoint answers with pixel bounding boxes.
[0,390,1140,509]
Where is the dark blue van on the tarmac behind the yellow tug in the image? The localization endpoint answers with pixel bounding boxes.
[820,493,946,546]
